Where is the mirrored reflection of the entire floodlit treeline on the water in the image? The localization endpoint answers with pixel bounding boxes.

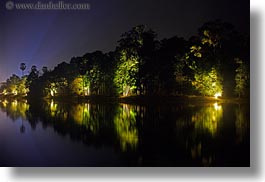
[0,100,249,166]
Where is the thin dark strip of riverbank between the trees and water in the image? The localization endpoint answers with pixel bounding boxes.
[0,96,249,105]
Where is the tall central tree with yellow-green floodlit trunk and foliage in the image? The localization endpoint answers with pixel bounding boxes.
[114,25,156,96]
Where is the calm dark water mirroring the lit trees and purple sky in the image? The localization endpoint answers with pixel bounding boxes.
[0,100,250,166]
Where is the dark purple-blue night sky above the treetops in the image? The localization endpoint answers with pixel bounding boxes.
[0,0,249,81]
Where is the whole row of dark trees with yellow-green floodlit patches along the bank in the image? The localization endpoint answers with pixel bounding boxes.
[0,20,250,98]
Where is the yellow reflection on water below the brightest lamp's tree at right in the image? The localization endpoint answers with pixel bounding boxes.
[186,103,223,166]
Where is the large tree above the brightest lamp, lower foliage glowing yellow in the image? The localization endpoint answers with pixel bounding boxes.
[186,20,239,95]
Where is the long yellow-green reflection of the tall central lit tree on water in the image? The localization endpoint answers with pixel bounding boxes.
[114,104,138,151]
